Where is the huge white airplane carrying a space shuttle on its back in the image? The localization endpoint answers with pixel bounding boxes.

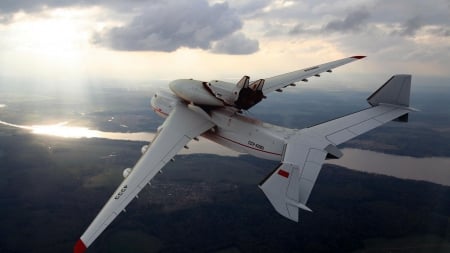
[74,56,415,253]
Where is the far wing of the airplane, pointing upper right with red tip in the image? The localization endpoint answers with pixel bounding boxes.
[262,56,365,95]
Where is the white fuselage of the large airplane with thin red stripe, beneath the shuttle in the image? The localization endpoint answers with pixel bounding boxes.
[151,82,295,161]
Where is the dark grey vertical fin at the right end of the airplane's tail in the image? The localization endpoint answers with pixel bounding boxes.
[367,75,411,107]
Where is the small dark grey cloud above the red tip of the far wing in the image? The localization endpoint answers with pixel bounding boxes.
[323,10,370,32]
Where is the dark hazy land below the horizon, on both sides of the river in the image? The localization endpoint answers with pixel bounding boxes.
[0,77,450,253]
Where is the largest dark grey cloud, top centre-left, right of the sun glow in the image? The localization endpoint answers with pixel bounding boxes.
[94,1,250,52]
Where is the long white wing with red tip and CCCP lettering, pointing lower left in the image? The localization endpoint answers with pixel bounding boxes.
[74,103,214,253]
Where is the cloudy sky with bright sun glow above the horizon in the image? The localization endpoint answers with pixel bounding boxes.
[0,0,450,87]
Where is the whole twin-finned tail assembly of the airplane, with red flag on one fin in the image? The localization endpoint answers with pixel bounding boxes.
[259,75,414,221]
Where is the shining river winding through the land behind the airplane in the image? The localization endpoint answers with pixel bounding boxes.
[0,118,450,186]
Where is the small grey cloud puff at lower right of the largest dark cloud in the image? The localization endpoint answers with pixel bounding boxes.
[212,33,259,54]
